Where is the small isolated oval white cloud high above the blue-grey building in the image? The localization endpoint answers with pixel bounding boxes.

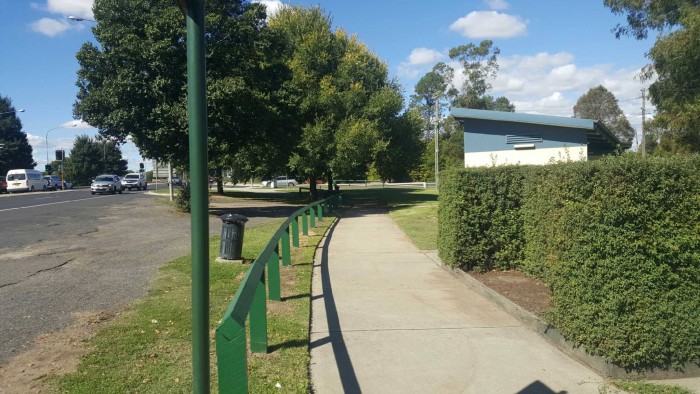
[450,11,527,38]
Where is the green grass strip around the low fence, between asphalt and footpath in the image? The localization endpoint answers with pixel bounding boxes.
[49,217,334,393]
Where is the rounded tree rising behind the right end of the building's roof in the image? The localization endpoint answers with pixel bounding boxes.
[574,85,634,144]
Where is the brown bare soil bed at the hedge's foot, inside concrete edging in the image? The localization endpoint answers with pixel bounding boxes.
[469,271,552,317]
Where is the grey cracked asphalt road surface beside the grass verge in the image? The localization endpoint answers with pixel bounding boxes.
[0,189,296,365]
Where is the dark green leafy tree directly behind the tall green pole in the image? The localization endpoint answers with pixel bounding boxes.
[74,0,289,182]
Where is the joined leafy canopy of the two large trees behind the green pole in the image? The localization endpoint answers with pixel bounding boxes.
[74,0,420,194]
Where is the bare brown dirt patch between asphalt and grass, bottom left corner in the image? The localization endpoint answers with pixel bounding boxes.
[0,312,114,393]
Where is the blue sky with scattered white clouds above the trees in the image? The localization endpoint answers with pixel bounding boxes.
[0,0,653,169]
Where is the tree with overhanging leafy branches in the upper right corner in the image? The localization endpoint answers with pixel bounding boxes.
[605,0,700,152]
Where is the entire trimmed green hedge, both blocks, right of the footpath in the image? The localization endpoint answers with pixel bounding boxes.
[438,155,700,369]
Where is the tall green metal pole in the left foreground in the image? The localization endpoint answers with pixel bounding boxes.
[178,0,210,394]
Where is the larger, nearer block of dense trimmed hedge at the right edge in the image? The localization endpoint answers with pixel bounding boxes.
[522,155,700,369]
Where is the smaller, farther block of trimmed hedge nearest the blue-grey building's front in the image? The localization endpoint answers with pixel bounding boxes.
[438,166,524,271]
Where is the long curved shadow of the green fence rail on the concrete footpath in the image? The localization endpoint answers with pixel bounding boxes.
[309,218,362,393]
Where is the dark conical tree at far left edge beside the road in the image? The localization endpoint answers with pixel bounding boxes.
[0,95,36,176]
